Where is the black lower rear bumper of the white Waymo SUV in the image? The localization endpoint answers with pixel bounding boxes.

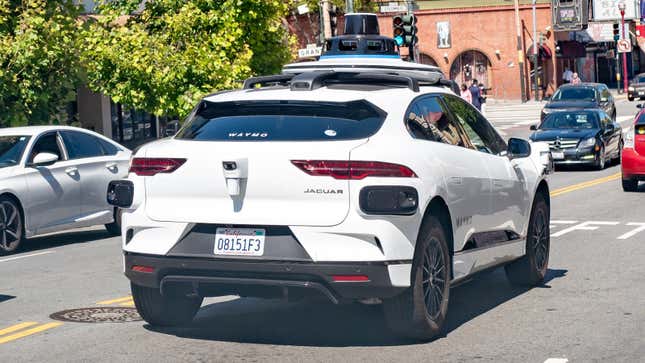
[124,252,410,303]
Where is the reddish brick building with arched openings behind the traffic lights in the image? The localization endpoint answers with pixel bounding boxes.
[289,0,562,100]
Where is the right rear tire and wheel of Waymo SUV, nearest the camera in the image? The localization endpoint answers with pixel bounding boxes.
[383,216,452,340]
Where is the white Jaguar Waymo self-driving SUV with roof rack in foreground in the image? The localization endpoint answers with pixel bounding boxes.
[108,59,550,339]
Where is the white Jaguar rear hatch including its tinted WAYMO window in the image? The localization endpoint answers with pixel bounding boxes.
[139,101,386,226]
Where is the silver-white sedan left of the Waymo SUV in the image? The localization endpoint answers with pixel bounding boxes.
[0,126,131,255]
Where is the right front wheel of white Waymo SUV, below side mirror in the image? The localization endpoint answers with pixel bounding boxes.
[504,194,551,286]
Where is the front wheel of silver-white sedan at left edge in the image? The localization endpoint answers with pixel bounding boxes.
[0,196,25,256]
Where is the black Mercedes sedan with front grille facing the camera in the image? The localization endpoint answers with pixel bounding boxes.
[530,109,623,170]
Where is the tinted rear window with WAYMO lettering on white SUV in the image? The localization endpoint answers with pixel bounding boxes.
[176,100,386,141]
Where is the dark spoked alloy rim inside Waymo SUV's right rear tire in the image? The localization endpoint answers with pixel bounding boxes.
[422,238,447,320]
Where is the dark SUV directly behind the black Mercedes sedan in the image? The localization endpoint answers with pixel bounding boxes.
[540,83,616,121]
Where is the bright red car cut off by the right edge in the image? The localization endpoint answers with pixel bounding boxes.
[621,109,645,192]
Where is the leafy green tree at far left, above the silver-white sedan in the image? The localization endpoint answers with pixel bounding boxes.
[0,0,79,127]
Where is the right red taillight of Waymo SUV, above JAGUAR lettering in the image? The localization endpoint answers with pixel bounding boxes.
[291,160,417,180]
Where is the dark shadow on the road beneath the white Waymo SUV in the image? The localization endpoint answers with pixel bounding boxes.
[144,269,566,347]
